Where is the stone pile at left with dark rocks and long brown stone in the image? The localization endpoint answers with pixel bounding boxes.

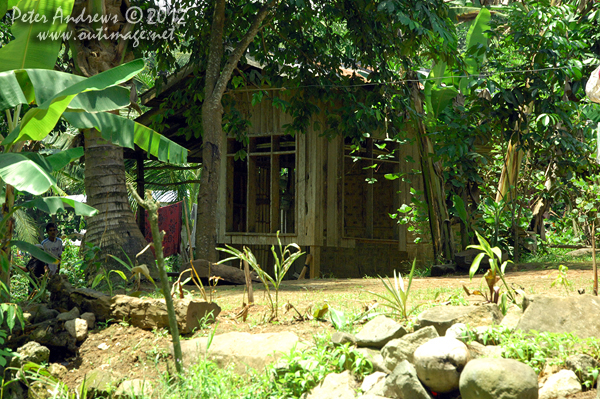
[0,275,221,398]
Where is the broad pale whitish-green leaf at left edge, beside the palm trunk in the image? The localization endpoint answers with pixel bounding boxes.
[0,153,56,195]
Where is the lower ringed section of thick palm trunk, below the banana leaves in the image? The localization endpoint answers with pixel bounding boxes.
[84,129,157,276]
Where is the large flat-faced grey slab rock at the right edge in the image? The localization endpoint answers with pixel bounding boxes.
[517,295,600,338]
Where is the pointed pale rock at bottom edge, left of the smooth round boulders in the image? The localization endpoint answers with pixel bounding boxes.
[368,360,431,399]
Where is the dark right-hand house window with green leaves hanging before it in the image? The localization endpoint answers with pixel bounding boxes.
[344,138,400,240]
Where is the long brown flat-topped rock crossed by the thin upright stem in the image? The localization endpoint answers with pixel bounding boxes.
[111,295,221,334]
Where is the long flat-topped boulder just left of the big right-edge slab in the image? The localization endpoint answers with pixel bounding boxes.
[415,304,503,336]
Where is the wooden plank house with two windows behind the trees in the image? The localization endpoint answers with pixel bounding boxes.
[138,65,432,278]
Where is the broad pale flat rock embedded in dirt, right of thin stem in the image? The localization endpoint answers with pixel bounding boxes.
[176,332,303,374]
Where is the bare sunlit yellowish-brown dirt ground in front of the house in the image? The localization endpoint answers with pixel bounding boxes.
[59,263,596,399]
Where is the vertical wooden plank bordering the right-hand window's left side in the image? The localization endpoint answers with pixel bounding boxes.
[327,136,342,247]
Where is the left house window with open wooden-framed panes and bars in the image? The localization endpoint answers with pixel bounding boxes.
[226,134,296,234]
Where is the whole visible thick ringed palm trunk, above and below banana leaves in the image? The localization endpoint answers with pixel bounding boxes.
[70,0,157,276]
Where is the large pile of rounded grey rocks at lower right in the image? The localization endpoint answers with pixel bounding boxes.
[306,296,600,399]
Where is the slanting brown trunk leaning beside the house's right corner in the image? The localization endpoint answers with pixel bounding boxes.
[411,78,454,262]
